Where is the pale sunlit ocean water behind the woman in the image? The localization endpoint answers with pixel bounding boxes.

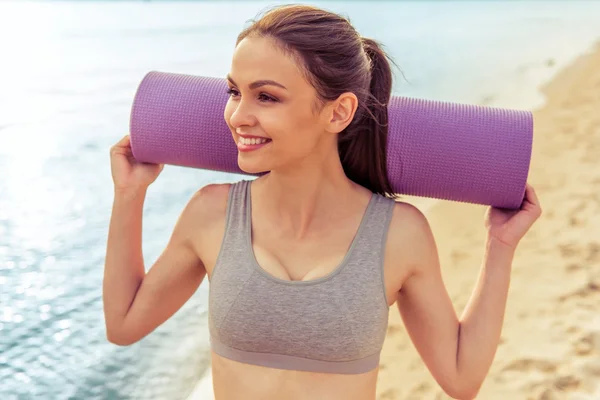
[0,1,600,399]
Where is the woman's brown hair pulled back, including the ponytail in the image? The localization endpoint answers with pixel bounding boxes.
[236,5,394,197]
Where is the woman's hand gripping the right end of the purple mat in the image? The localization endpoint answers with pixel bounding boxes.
[485,184,542,248]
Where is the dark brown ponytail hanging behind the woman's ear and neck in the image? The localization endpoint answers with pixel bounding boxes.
[338,38,395,197]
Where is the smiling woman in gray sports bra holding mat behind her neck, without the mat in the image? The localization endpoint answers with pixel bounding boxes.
[104,6,541,400]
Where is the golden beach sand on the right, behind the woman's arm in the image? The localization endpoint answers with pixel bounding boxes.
[377,44,600,400]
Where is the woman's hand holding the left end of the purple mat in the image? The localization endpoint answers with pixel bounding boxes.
[110,135,164,191]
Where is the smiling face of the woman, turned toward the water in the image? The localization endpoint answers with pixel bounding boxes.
[224,37,337,173]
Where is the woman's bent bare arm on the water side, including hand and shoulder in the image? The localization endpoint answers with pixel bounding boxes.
[102,135,220,345]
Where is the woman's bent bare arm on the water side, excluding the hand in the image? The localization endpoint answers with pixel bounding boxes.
[103,186,206,345]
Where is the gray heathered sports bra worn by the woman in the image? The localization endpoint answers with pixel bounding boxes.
[208,180,394,374]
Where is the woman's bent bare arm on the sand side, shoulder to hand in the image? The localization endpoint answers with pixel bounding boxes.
[386,185,541,399]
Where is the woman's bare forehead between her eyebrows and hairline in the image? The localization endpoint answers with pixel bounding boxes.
[231,38,305,88]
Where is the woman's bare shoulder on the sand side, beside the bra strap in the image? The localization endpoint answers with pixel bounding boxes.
[385,201,437,290]
